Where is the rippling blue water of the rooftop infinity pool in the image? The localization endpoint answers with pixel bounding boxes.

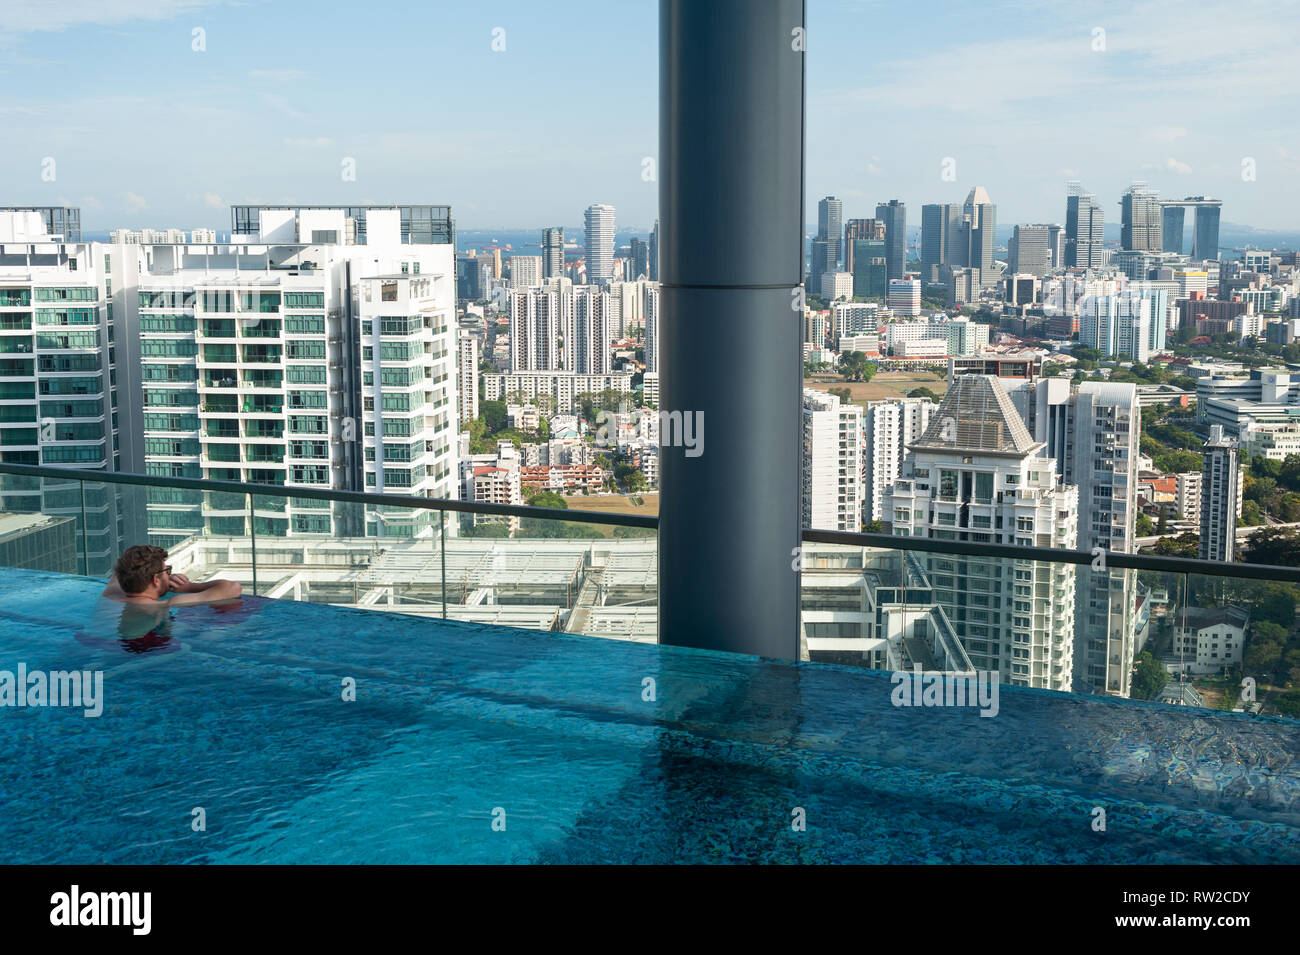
[0,569,1300,864]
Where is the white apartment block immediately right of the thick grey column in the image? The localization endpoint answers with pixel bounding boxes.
[800,388,862,531]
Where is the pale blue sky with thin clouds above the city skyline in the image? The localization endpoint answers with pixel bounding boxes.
[0,0,1300,231]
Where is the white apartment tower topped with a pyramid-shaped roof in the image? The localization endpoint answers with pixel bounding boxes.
[887,374,1079,690]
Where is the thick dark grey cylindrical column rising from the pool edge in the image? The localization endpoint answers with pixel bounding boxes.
[659,0,805,659]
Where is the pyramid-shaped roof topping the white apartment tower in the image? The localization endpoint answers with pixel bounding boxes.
[910,374,1043,456]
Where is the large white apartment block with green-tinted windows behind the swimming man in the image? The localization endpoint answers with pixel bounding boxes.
[111,207,459,546]
